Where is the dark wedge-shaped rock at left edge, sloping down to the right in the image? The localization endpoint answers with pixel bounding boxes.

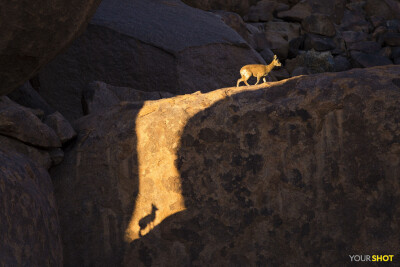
[0,96,61,148]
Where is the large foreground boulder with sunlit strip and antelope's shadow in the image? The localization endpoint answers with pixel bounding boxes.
[51,66,400,266]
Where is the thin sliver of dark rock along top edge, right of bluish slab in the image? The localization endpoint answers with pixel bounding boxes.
[182,0,259,15]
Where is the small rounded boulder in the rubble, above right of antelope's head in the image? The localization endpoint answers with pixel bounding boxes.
[301,14,336,37]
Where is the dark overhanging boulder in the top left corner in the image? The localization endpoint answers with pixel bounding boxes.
[0,0,100,95]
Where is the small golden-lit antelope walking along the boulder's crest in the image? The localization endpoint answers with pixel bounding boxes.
[236,55,282,87]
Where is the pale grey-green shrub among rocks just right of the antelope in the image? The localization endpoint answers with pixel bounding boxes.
[285,50,335,73]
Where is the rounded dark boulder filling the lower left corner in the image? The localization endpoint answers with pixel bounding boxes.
[0,151,63,267]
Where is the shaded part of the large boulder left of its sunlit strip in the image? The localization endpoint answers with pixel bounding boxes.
[50,103,143,266]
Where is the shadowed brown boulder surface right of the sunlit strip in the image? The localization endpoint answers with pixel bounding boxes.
[124,69,400,266]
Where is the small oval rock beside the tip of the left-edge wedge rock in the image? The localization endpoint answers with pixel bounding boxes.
[44,111,76,144]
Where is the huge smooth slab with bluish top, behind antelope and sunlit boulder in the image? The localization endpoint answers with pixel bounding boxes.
[39,0,265,121]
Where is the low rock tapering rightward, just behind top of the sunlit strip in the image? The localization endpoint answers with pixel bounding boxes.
[82,81,174,115]
